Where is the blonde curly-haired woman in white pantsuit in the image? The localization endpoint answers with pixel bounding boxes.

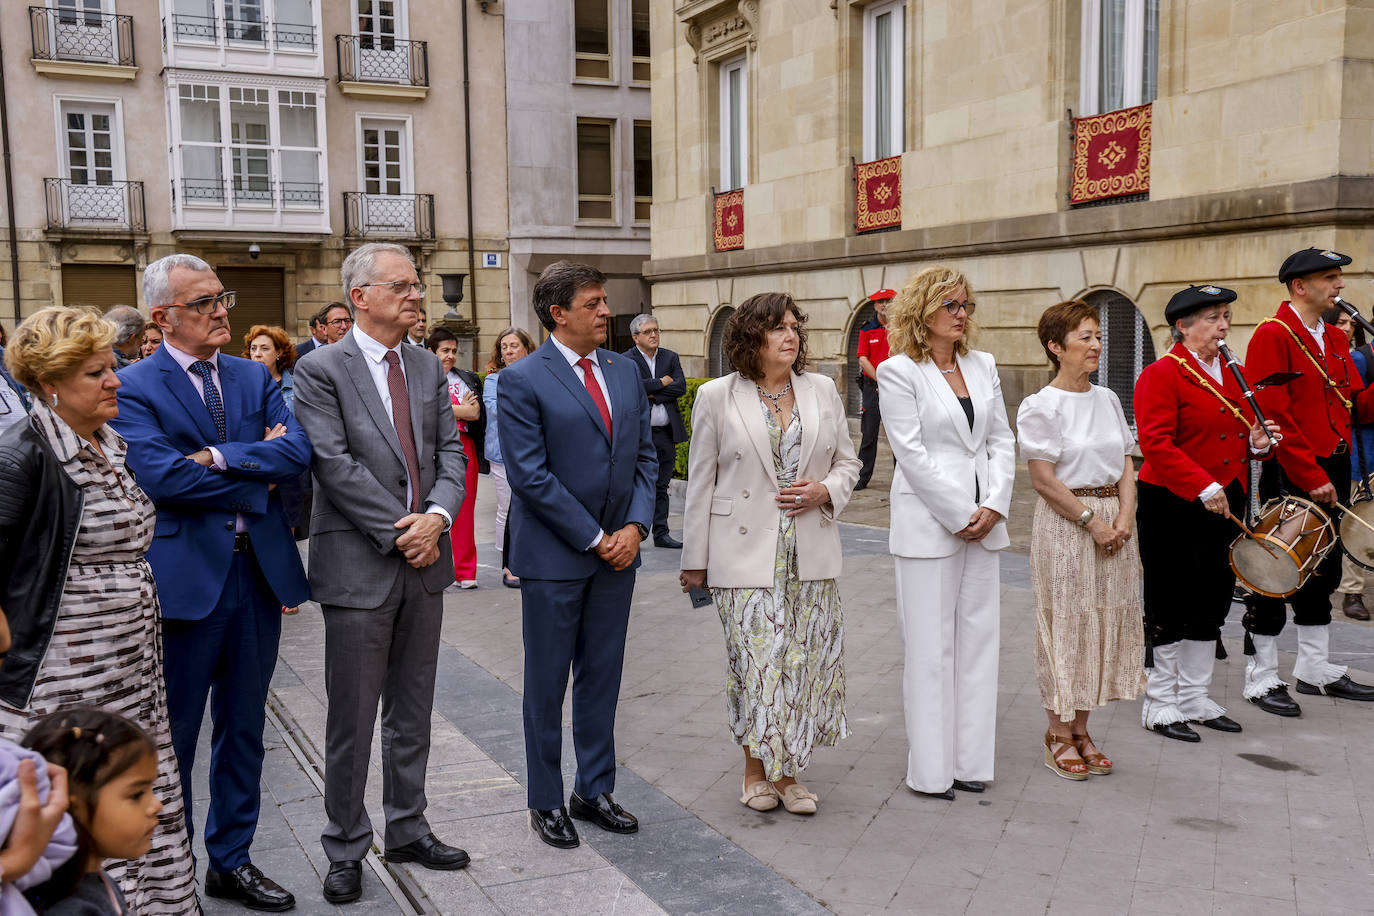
[878,266,1015,799]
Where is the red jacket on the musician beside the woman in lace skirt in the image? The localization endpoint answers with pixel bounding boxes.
[1135,343,1254,500]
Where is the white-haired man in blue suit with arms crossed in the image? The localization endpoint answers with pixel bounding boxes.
[114,254,311,911]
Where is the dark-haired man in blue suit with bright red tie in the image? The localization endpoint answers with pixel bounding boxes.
[497,261,658,849]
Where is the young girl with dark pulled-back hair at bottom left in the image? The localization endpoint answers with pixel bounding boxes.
[23,706,162,916]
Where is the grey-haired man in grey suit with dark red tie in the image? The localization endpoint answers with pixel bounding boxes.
[295,242,469,904]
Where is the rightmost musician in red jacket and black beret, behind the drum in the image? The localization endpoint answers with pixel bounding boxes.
[1243,249,1374,715]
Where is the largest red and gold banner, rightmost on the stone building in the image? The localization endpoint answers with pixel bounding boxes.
[1069,104,1150,203]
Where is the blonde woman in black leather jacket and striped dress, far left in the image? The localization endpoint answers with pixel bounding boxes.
[0,306,198,913]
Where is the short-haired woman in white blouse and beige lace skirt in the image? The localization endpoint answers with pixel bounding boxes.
[1017,299,1145,780]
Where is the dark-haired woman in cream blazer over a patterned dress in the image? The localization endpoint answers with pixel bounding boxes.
[682,293,859,814]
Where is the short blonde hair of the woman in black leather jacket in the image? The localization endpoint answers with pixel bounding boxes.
[4,305,120,398]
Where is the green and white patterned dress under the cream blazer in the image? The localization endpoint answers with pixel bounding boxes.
[712,401,849,781]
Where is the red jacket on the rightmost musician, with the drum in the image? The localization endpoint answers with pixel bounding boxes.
[1245,301,1374,492]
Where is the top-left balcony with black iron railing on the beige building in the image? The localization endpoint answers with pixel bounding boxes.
[29,7,139,80]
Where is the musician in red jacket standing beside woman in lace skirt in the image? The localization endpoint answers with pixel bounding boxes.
[1135,286,1278,742]
